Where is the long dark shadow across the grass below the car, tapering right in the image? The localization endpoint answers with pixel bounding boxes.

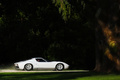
[0,72,116,80]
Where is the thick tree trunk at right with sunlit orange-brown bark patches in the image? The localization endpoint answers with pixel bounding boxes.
[94,0,120,72]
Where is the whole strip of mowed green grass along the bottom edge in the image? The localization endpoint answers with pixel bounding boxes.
[0,72,120,80]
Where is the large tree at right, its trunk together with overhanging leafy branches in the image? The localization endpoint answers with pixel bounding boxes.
[54,0,120,72]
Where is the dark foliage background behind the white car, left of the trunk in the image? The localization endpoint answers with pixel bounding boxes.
[0,0,95,69]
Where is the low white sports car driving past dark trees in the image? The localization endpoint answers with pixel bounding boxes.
[14,57,69,71]
